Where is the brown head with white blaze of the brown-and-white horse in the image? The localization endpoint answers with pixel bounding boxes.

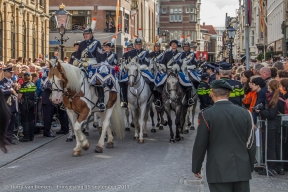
[48,61,68,105]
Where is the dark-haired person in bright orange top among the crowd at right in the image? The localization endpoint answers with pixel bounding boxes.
[241,70,257,112]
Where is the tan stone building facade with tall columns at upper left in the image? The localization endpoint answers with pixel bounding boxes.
[0,0,49,62]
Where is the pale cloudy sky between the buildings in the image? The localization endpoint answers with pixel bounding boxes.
[200,0,239,27]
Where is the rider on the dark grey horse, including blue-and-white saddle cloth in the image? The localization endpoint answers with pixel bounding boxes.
[155,37,194,107]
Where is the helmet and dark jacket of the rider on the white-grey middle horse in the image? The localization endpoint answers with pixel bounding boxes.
[128,38,150,66]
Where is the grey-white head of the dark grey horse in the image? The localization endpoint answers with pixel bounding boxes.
[166,71,180,100]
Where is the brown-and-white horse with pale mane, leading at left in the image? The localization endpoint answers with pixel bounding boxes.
[48,62,124,157]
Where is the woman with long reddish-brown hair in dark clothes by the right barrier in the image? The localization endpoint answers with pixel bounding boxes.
[256,79,284,176]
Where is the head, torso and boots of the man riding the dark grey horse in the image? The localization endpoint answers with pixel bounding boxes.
[162,40,194,106]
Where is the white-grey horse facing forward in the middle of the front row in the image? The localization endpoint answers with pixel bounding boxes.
[125,60,153,143]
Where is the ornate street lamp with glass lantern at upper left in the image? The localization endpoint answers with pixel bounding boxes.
[53,3,72,60]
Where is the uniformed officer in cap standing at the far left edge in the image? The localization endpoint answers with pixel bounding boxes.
[0,67,18,145]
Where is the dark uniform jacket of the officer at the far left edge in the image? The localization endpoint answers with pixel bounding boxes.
[0,78,18,113]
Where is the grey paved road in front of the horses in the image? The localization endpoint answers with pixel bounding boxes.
[0,108,288,192]
